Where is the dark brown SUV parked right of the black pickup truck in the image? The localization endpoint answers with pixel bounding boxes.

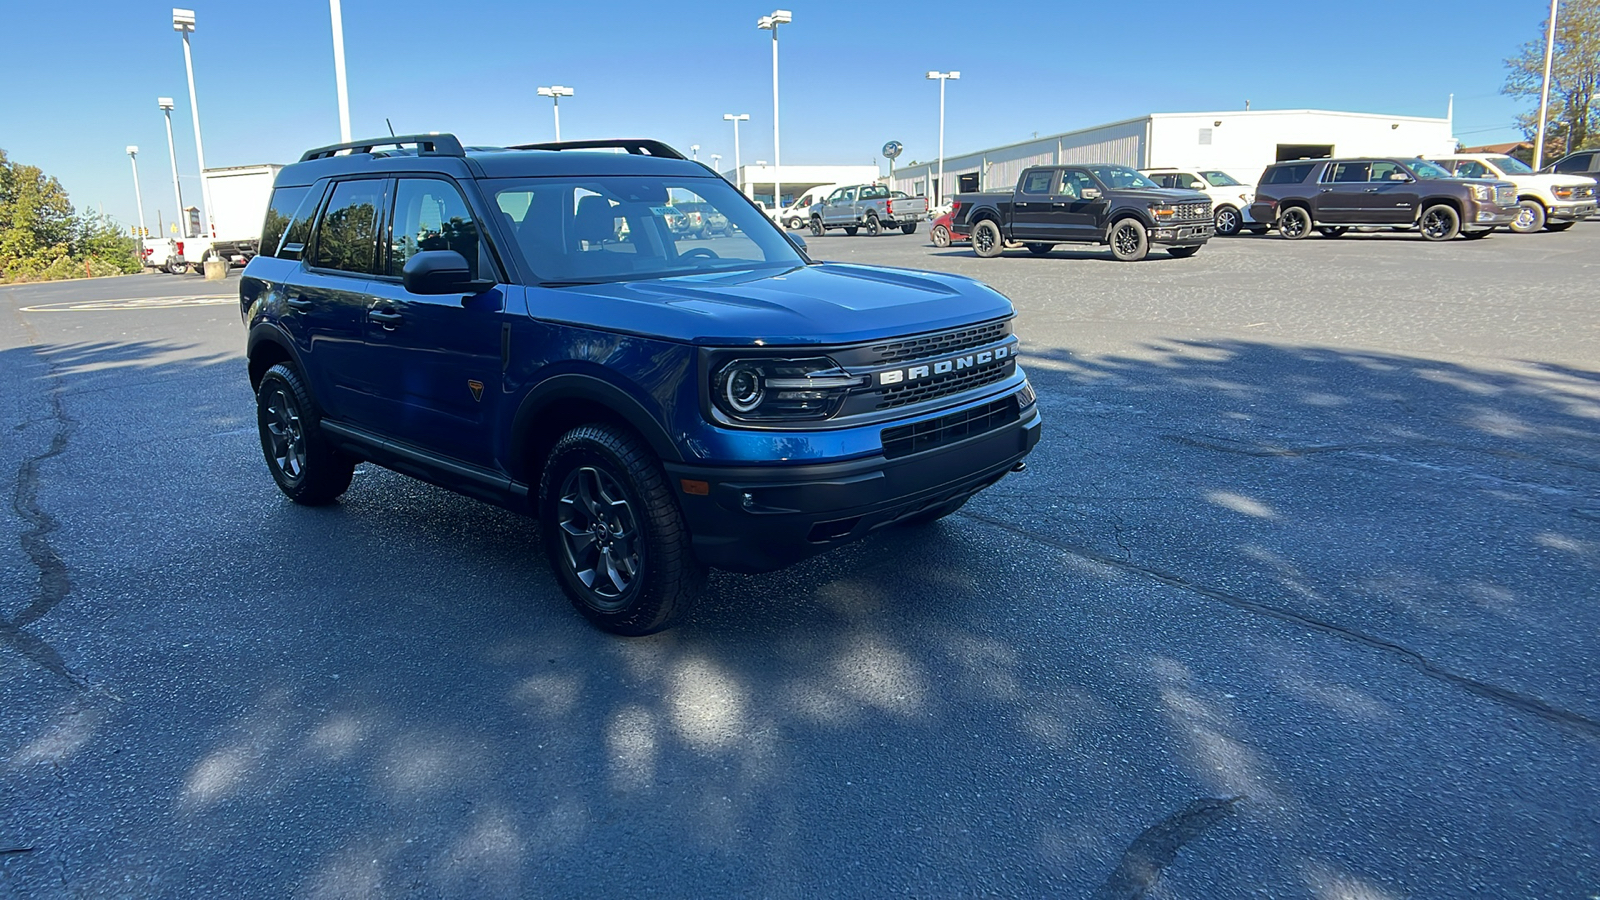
[1250,159,1518,240]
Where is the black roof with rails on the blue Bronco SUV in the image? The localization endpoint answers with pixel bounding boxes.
[277,135,717,186]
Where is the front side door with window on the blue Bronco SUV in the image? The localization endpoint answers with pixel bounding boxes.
[365,178,506,466]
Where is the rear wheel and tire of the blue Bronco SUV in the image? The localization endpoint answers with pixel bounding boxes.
[256,362,355,506]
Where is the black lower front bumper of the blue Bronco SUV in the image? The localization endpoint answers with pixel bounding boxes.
[666,404,1042,572]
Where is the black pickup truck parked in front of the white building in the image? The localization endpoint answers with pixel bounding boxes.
[950,163,1216,261]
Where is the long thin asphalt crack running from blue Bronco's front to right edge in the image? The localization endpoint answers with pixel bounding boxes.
[958,509,1600,738]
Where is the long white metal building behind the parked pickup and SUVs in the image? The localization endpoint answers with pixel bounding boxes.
[894,109,1456,200]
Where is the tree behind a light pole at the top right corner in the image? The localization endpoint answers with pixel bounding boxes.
[1501,0,1600,165]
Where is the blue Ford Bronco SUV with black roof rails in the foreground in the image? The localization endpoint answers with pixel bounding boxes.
[240,135,1040,634]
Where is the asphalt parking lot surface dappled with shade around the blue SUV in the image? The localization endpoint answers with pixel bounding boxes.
[0,224,1600,900]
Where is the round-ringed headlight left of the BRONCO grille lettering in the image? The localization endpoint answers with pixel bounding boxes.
[710,357,867,421]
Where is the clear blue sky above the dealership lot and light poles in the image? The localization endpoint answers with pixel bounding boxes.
[0,0,1549,227]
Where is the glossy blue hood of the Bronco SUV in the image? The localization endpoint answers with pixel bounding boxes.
[528,263,1013,346]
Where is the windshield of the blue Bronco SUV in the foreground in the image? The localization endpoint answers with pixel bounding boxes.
[483,176,805,283]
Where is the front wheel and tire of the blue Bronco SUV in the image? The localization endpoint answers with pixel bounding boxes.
[539,424,706,634]
